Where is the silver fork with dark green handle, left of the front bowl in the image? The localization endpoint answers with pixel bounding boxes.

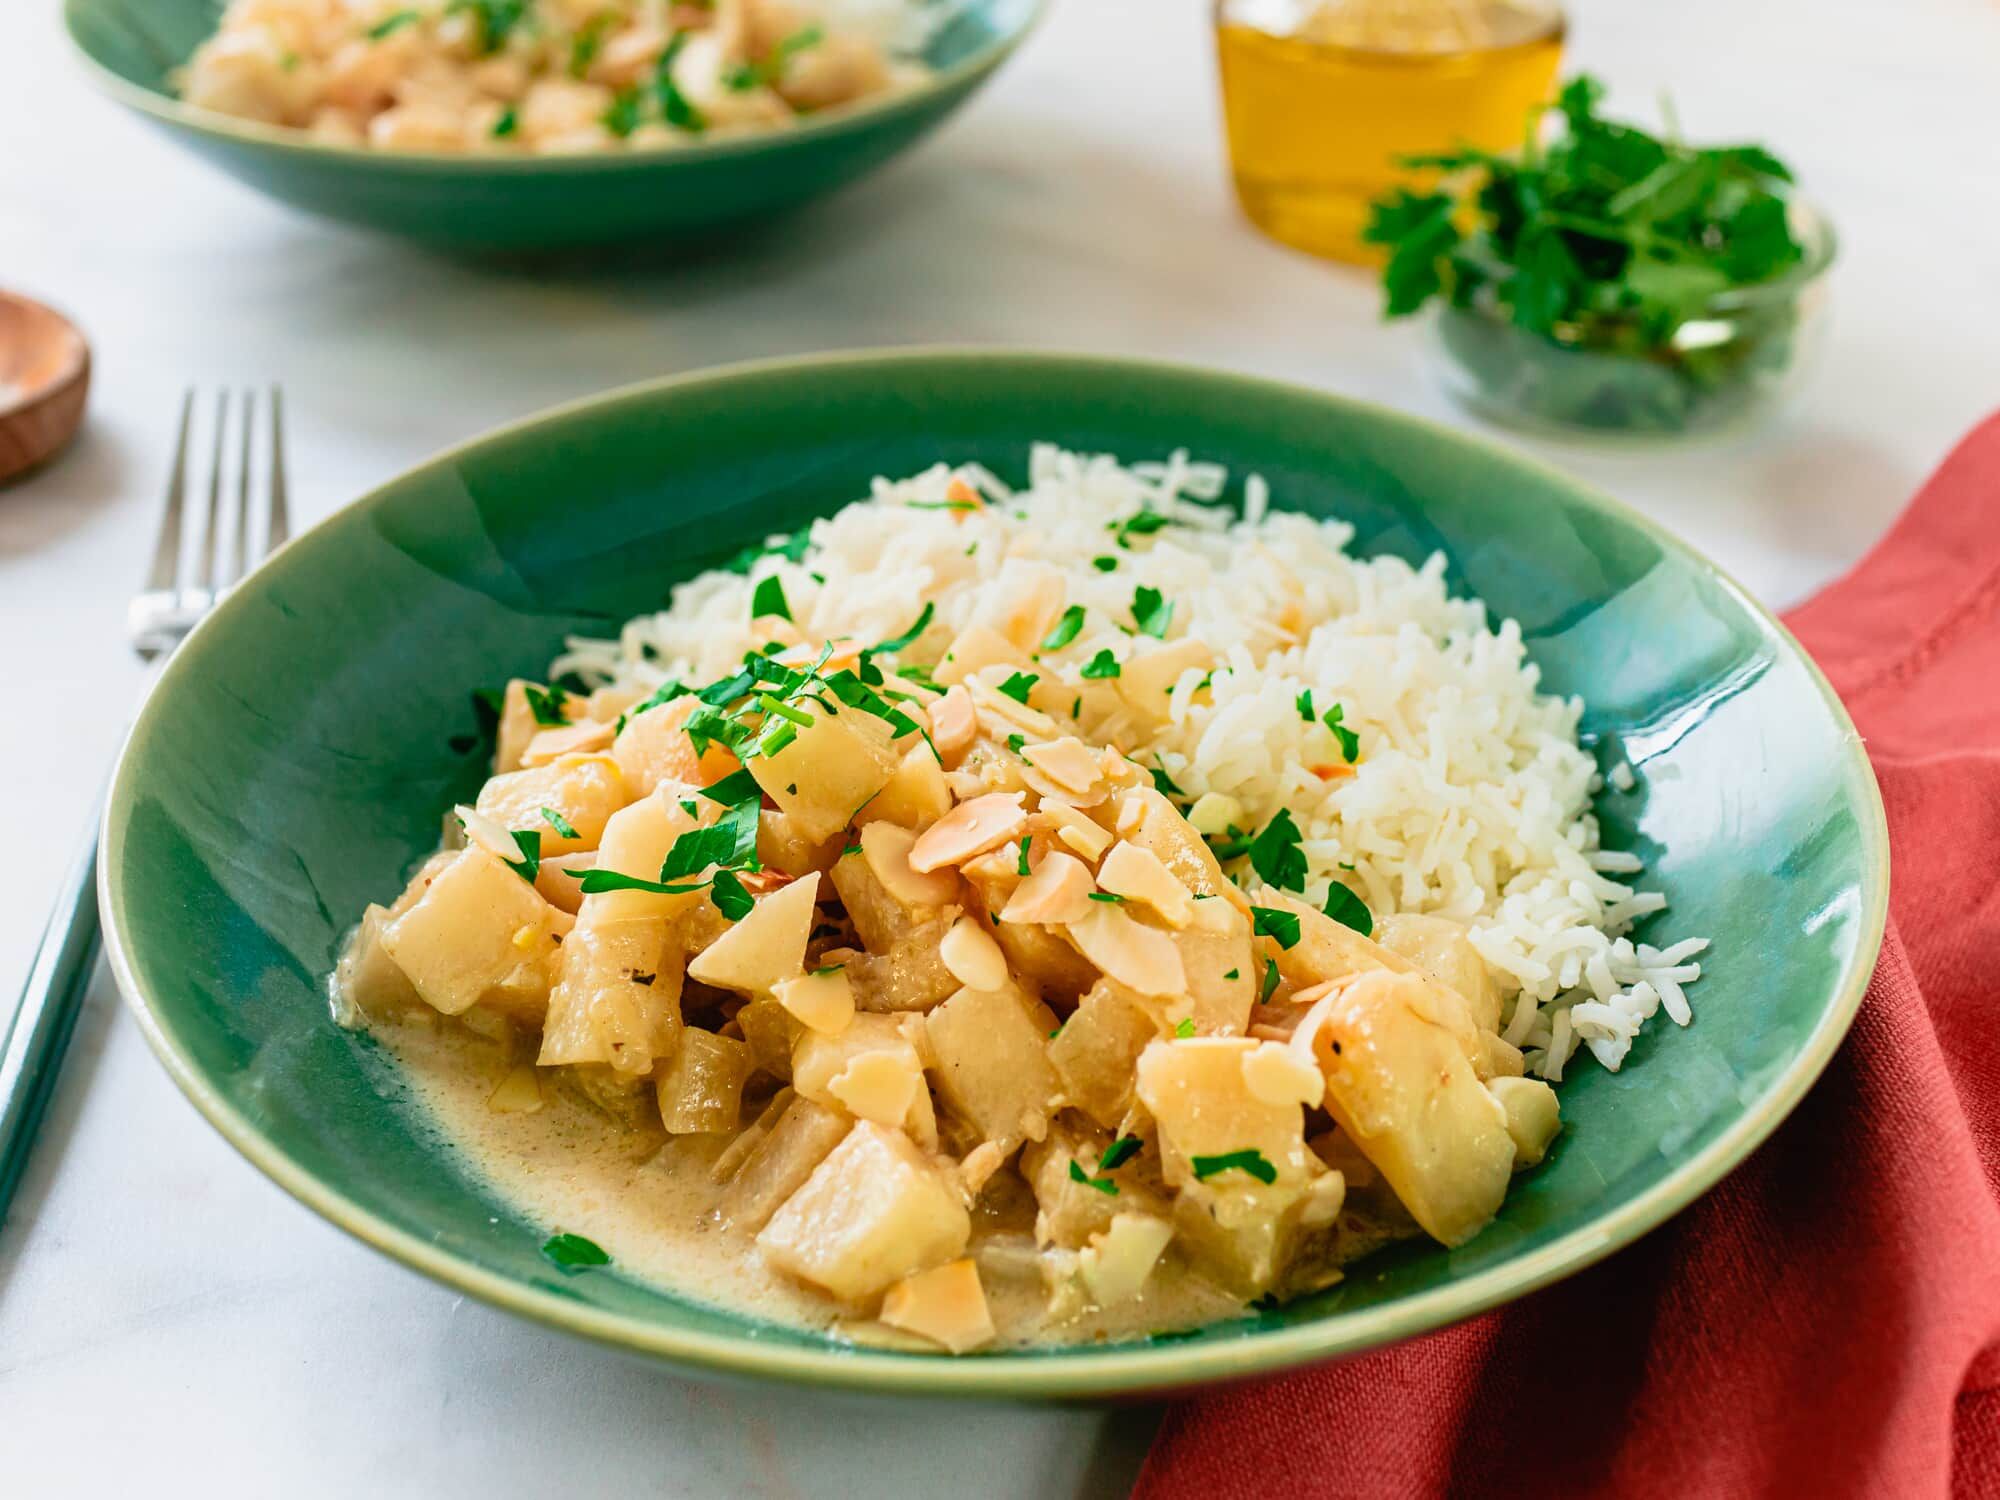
[0,386,290,1224]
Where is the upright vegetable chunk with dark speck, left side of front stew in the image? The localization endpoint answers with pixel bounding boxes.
[538,896,682,1076]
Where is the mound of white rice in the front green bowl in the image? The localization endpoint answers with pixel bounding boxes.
[554,444,1708,1080]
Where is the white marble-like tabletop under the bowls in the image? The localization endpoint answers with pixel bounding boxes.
[0,0,2000,1500]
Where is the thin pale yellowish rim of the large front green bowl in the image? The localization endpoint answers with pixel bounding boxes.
[98,346,1888,1400]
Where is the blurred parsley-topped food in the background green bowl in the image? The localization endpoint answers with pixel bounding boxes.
[178,0,934,154]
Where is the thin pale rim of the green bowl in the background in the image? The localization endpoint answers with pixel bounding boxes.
[62,0,1054,176]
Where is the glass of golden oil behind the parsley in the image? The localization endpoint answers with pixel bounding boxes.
[1216,0,1564,264]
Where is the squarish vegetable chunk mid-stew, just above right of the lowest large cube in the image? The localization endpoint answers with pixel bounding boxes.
[924,988,1058,1150]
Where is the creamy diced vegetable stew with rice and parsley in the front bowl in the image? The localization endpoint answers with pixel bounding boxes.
[336,446,1704,1352]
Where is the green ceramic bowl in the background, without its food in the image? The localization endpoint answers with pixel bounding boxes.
[64,0,1044,252]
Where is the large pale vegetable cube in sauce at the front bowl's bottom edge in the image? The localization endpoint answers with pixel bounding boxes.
[756,1120,972,1304]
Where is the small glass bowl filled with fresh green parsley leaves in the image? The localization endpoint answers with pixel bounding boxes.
[1368,76,1832,432]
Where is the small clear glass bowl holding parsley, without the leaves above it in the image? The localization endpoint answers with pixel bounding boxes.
[1432,196,1834,438]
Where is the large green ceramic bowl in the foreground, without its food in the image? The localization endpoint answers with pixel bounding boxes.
[102,352,1888,1396]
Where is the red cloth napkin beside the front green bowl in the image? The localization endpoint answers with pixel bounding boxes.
[1136,416,2000,1500]
